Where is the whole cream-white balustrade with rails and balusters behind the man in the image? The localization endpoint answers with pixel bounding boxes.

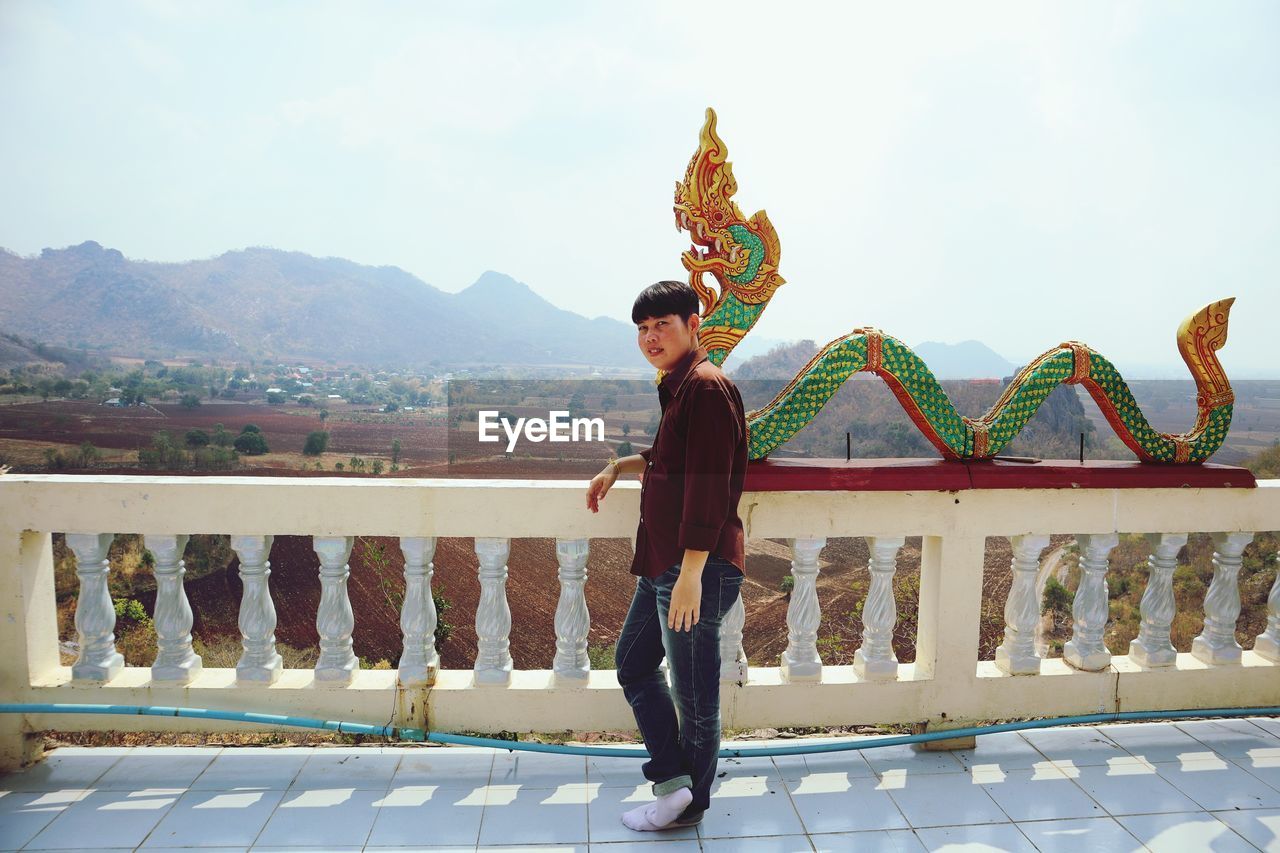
[0,474,1280,768]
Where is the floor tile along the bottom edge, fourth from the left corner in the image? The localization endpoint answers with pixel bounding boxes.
[255,786,384,849]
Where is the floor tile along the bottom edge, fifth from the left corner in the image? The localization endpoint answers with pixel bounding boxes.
[367,785,484,848]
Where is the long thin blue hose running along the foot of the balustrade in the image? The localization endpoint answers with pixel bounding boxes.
[0,703,1280,758]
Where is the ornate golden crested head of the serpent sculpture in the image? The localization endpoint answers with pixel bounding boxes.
[675,108,783,325]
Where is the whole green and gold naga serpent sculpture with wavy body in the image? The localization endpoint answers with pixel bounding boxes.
[675,109,1235,464]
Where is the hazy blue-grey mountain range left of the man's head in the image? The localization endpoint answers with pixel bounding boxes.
[0,241,643,368]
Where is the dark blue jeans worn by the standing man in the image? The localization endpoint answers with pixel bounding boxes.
[614,556,742,817]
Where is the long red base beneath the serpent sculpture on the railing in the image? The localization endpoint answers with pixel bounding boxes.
[745,459,1257,492]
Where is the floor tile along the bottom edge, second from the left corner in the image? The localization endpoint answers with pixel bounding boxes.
[26,790,182,850]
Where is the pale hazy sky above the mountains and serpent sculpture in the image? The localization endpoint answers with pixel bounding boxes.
[0,0,1280,378]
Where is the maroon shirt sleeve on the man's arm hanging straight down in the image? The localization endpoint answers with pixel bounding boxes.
[678,382,741,551]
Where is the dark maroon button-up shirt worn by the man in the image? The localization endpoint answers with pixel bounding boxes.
[631,347,746,578]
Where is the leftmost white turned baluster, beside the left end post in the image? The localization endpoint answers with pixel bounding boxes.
[67,533,124,681]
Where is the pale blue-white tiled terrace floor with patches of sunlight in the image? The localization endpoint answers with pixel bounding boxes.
[0,719,1280,853]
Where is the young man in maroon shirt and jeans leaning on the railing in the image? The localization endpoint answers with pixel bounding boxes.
[586,282,746,831]
